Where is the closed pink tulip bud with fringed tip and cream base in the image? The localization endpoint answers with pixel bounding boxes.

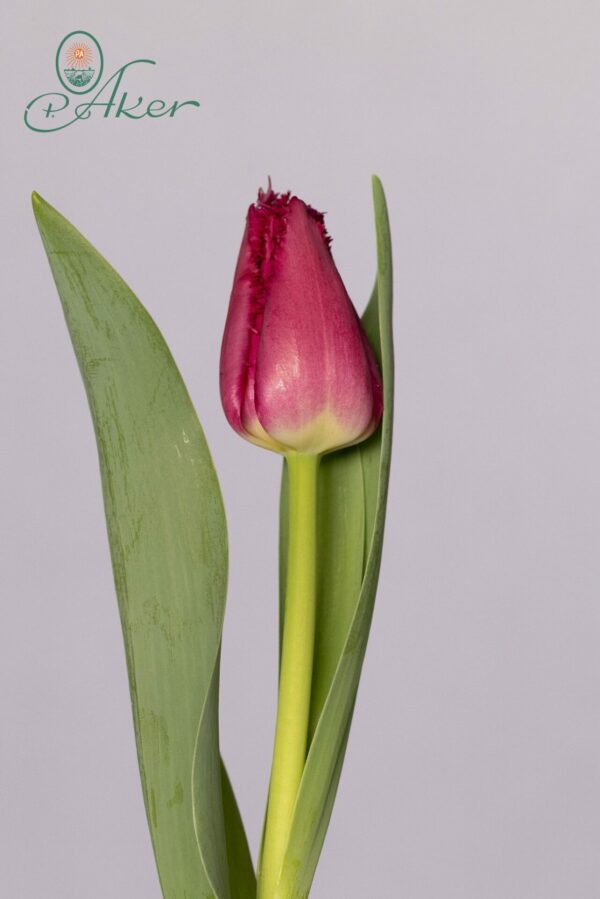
[220,184,382,454]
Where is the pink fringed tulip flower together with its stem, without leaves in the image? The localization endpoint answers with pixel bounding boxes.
[220,182,382,899]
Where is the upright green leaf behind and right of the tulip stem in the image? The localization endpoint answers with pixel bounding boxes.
[277,177,394,899]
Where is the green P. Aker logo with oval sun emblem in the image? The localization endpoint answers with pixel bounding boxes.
[23,31,200,134]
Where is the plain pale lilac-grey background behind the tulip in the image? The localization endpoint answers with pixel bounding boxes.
[0,0,600,899]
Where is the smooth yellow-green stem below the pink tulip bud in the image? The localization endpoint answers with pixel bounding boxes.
[258,454,320,899]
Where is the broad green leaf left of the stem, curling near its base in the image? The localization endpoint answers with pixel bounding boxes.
[33,194,256,899]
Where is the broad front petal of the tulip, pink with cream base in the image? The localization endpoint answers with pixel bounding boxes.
[255,198,380,452]
